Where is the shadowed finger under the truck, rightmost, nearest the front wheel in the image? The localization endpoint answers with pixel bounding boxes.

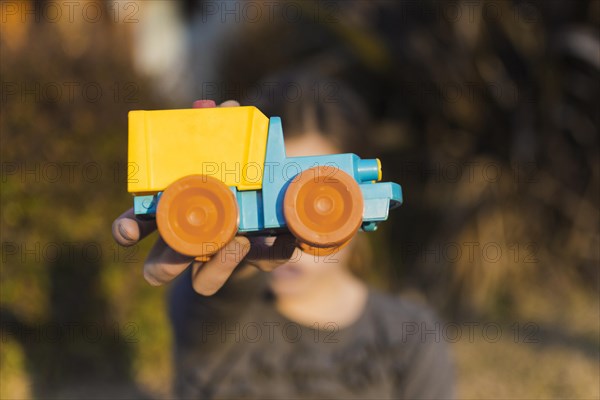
[244,234,296,272]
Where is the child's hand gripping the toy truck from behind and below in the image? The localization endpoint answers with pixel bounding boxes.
[112,100,295,296]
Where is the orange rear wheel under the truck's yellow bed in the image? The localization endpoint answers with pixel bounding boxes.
[156,175,238,260]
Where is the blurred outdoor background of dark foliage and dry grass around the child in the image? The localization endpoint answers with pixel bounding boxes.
[0,0,600,399]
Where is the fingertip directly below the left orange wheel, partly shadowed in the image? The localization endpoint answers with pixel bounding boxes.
[144,236,194,286]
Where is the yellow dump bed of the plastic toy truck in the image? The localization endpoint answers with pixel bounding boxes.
[127,107,269,195]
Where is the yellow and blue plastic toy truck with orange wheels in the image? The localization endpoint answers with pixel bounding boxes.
[128,100,402,260]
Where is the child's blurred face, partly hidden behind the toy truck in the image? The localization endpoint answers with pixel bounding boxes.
[270,133,352,296]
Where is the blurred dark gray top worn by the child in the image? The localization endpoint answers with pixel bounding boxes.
[169,270,454,399]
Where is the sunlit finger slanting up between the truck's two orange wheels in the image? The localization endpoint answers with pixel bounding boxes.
[192,236,250,296]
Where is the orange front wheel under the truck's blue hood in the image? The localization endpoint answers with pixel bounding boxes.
[283,166,364,255]
